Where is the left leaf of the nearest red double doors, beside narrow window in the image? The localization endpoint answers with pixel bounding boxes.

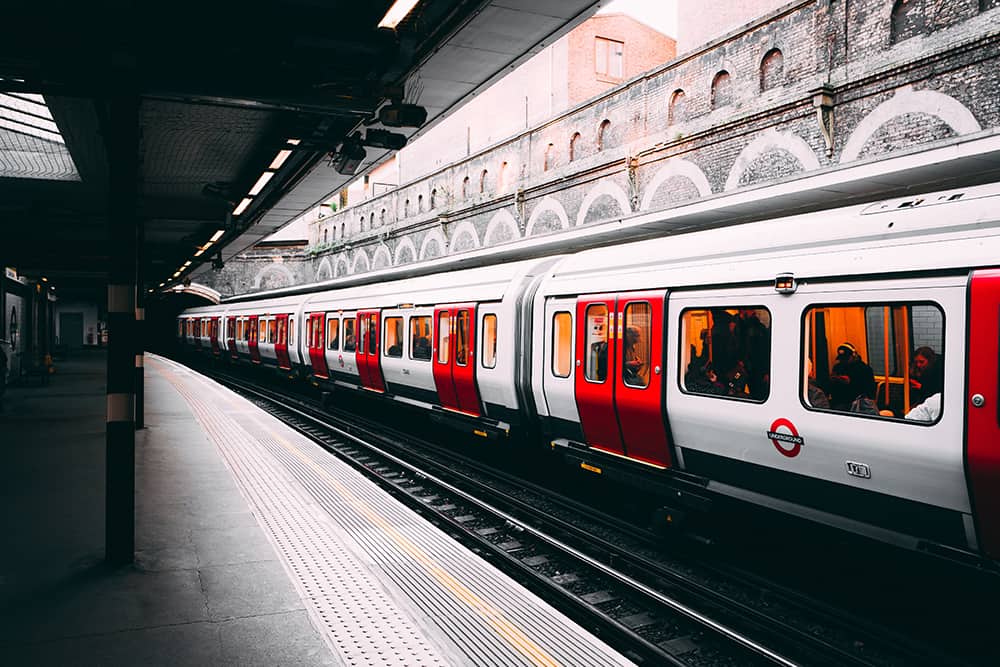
[575,294,625,454]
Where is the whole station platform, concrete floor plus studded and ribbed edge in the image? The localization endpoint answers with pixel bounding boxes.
[0,352,630,666]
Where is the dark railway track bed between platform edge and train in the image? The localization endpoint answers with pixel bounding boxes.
[209,374,961,665]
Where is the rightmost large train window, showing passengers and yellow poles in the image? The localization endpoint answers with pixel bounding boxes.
[802,302,944,424]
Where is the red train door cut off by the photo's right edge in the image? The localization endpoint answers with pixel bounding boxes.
[965,269,1000,559]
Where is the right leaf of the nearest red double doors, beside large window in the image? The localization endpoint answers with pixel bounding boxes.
[615,292,670,466]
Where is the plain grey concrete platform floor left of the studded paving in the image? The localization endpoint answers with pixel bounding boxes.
[0,351,338,665]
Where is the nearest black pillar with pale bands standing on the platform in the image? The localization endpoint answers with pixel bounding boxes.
[104,92,139,565]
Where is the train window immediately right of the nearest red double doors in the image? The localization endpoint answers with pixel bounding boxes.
[680,306,771,402]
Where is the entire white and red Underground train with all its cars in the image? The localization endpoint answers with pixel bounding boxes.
[176,184,1000,568]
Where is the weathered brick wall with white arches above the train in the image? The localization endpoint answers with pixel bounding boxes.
[223,0,1000,290]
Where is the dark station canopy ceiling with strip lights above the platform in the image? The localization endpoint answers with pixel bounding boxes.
[0,0,601,294]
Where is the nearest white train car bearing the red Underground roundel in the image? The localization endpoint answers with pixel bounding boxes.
[533,186,1000,560]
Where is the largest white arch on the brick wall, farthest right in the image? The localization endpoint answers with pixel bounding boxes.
[840,86,982,163]
